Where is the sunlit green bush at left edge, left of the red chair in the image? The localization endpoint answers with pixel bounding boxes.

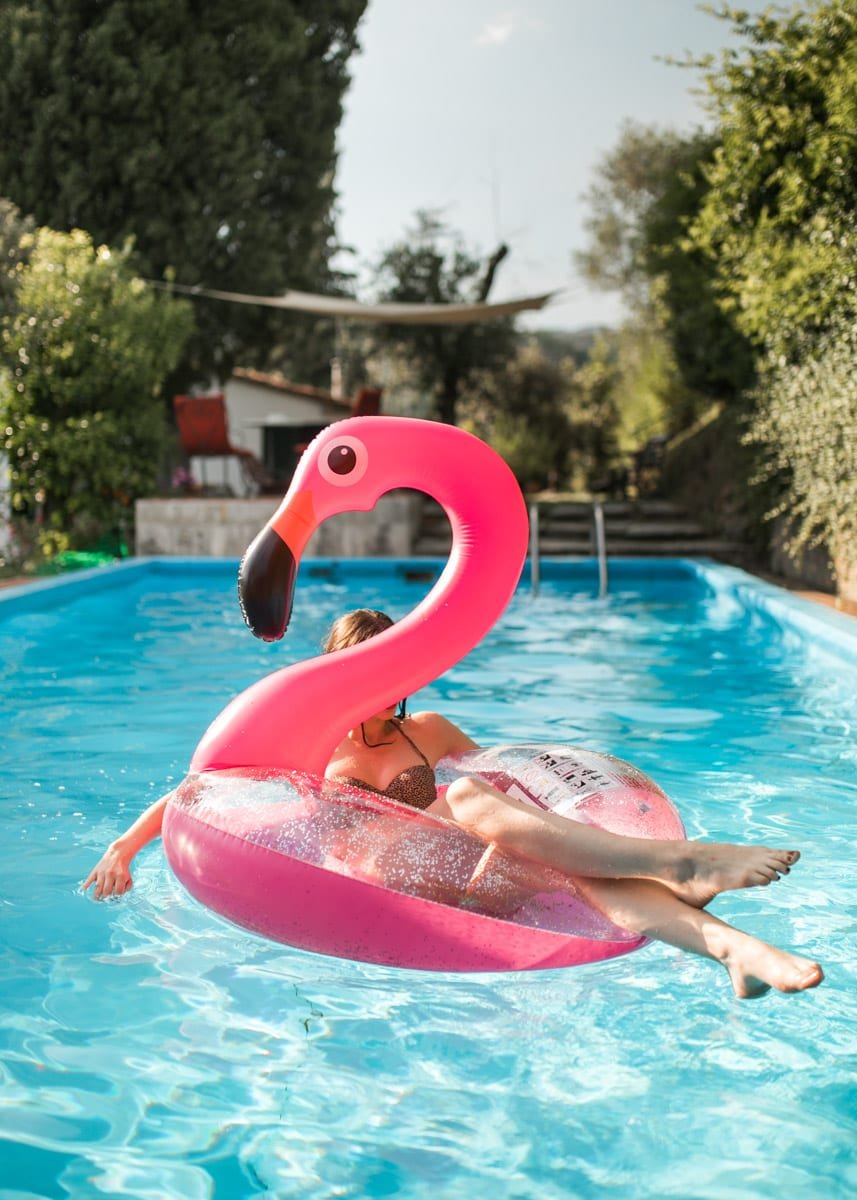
[0,229,193,552]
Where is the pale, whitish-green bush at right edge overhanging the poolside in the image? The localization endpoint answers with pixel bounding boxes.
[747,322,857,578]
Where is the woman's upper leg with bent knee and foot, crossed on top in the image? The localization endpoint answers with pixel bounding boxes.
[431,778,799,908]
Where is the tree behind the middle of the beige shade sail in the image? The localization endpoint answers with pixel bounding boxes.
[376,212,515,425]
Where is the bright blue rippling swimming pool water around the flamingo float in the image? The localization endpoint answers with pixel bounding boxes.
[0,560,857,1200]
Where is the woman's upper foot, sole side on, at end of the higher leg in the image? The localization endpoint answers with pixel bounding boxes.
[654,841,801,908]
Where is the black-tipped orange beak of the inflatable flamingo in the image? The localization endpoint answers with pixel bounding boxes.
[238,492,317,642]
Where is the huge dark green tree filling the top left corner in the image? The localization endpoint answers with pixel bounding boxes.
[0,0,366,382]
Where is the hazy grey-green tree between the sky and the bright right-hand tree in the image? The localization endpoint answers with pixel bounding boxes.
[577,122,754,410]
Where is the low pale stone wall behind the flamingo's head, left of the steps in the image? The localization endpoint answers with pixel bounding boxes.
[134,492,420,558]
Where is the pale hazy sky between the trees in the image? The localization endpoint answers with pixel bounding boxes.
[336,0,763,329]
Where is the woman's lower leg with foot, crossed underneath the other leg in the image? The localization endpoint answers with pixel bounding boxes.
[579,878,825,998]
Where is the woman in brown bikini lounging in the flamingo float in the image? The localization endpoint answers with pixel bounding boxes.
[84,608,823,998]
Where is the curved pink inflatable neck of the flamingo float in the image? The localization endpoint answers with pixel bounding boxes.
[191,452,528,775]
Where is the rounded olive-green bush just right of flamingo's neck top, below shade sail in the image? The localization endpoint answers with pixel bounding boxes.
[462,342,573,488]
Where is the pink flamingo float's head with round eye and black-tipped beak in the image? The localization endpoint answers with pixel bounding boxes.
[239,416,458,642]
